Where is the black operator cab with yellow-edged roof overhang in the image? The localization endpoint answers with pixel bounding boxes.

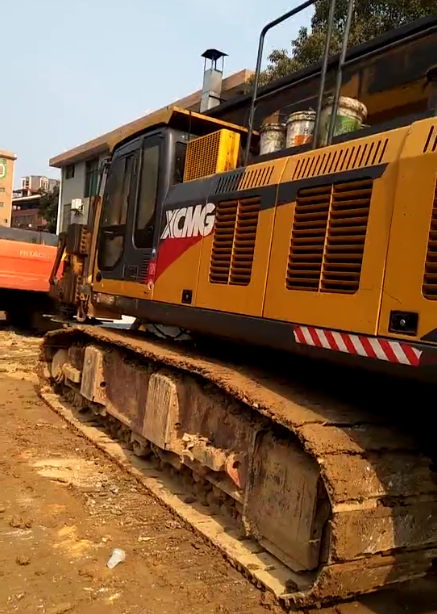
[96,108,250,289]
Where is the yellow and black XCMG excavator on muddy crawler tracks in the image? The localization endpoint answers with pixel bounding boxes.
[40,1,437,608]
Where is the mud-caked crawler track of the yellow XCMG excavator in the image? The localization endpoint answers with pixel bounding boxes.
[37,326,437,608]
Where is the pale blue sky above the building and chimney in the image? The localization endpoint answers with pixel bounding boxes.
[0,0,312,184]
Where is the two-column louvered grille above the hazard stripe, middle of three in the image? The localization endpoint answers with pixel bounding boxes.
[286,179,373,294]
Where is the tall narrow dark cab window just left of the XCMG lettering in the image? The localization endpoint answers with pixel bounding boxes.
[134,141,159,249]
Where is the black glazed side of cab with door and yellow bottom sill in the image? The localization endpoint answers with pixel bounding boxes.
[94,134,163,298]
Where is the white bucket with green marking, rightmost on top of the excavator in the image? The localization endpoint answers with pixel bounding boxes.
[320,96,367,146]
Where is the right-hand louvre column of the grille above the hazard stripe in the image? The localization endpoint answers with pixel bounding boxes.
[320,179,373,294]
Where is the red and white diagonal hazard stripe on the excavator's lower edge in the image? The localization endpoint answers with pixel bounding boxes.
[294,326,422,367]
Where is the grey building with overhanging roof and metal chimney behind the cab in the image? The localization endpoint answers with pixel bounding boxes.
[49,63,253,233]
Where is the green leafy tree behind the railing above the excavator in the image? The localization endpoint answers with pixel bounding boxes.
[252,0,437,85]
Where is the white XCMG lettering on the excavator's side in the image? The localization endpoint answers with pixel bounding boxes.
[161,203,215,240]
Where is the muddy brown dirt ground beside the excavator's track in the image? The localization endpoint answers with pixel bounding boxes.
[0,329,437,614]
